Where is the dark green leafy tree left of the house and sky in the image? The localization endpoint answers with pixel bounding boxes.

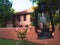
[0,0,14,27]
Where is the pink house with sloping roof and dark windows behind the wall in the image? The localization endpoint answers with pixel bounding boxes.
[7,8,33,27]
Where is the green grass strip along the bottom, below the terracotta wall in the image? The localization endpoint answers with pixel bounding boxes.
[0,38,44,45]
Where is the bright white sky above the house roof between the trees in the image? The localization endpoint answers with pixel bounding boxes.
[12,0,32,11]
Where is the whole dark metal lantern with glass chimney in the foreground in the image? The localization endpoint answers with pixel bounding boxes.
[34,3,55,39]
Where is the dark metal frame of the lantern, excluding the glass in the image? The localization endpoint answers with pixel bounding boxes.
[34,2,55,39]
